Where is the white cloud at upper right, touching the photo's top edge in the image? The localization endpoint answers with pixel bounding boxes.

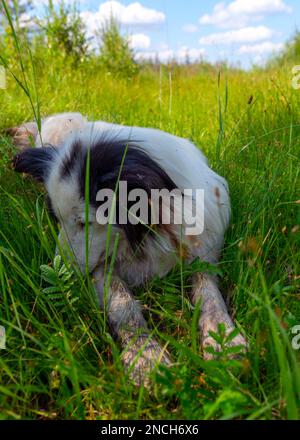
[199,0,292,28]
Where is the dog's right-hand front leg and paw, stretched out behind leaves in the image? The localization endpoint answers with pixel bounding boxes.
[191,273,247,359]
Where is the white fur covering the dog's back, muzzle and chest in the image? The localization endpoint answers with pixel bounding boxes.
[36,113,230,285]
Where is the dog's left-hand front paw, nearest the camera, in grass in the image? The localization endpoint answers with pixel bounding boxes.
[122,336,171,387]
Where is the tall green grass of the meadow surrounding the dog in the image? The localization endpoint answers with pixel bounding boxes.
[0,39,300,419]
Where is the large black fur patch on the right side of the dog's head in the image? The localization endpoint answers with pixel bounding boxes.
[78,139,177,252]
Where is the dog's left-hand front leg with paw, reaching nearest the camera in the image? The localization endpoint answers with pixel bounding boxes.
[94,269,170,385]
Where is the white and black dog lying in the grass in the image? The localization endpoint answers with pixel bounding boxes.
[11,113,246,381]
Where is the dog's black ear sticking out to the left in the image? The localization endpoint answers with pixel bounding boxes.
[13,147,56,182]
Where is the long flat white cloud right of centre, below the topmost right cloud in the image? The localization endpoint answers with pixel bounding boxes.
[199,26,275,45]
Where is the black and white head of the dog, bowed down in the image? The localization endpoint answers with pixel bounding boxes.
[13,126,175,272]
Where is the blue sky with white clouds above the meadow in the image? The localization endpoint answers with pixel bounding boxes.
[32,0,300,68]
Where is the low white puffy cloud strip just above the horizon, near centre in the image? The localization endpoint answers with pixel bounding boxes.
[135,46,205,64]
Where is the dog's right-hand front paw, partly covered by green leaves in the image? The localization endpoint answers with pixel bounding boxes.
[201,329,248,360]
